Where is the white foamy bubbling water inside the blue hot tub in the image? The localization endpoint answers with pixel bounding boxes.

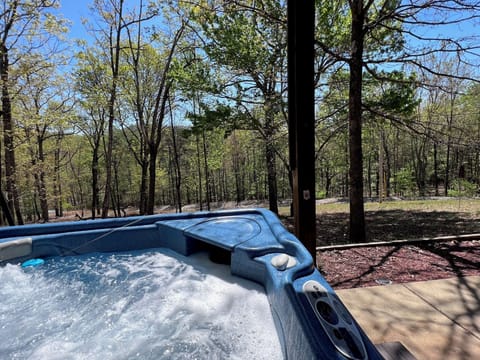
[0,249,283,360]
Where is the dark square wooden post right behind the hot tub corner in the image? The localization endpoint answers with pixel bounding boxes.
[287,0,316,264]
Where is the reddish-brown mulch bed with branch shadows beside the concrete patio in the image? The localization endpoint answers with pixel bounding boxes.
[317,241,480,289]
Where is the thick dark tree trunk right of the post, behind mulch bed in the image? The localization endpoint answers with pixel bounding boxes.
[348,0,366,242]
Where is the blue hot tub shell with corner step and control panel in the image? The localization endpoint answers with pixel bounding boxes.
[0,209,382,360]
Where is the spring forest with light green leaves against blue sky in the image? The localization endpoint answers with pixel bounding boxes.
[0,0,480,240]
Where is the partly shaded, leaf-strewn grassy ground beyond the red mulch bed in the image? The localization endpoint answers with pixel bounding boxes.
[281,199,480,246]
